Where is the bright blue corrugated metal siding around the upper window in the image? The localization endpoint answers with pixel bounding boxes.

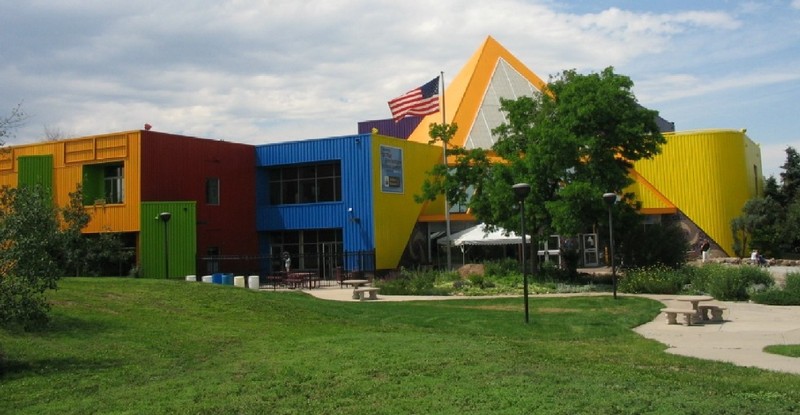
[256,134,375,251]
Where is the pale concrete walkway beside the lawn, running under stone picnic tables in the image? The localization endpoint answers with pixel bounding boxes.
[296,286,800,374]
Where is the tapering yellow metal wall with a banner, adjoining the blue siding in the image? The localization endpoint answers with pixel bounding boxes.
[372,135,442,269]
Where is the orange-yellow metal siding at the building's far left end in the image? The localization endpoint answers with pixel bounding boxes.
[0,131,141,233]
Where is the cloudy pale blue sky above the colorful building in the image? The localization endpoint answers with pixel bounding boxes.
[0,0,800,176]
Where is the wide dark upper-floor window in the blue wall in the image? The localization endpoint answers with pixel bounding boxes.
[269,161,342,205]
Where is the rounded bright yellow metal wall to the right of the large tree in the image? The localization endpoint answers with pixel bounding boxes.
[634,130,761,255]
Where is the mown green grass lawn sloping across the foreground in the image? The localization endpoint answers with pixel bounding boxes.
[0,278,800,415]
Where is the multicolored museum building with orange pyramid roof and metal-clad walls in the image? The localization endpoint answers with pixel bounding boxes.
[0,37,763,279]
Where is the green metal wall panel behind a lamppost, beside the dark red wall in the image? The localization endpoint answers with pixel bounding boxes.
[139,202,197,279]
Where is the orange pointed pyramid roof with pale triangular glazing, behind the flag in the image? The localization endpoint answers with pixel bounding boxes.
[408,36,545,149]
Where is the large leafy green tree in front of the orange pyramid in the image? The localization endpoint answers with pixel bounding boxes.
[416,68,665,272]
